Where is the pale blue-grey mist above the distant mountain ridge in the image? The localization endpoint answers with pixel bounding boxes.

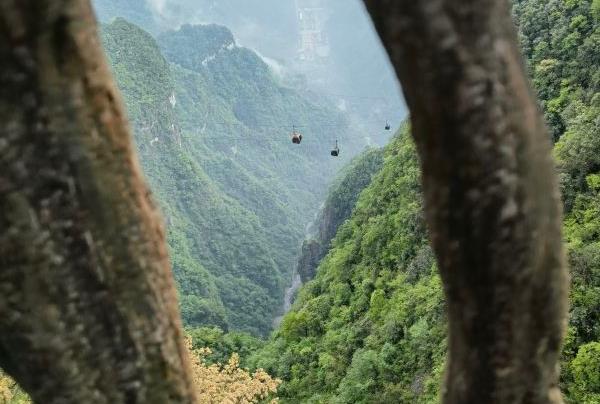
[95,0,406,137]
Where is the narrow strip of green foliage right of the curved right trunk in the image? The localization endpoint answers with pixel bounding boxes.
[540,0,600,403]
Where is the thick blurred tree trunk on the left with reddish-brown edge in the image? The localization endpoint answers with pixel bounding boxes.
[0,0,194,404]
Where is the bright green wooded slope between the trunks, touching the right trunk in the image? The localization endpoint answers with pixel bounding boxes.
[250,127,445,403]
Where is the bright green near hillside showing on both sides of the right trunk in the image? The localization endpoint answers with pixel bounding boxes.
[250,0,600,404]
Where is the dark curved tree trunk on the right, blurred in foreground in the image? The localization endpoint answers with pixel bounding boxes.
[365,0,568,404]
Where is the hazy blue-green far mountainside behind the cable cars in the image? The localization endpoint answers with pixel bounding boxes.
[102,19,360,335]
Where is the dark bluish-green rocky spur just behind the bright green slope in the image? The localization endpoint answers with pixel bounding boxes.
[296,148,383,283]
